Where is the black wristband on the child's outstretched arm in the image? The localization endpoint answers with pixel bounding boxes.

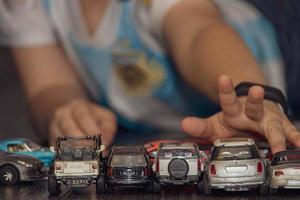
[235,82,288,116]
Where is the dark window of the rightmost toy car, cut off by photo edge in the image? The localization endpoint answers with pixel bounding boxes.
[272,150,300,165]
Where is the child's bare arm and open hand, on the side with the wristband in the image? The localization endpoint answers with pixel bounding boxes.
[162,0,300,152]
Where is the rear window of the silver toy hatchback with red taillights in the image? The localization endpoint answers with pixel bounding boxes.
[212,146,259,160]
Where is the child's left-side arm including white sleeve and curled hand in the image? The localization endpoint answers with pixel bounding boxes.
[0,0,116,144]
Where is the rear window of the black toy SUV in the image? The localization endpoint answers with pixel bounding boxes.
[111,154,147,167]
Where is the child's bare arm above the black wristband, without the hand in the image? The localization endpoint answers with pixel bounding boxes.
[163,0,265,101]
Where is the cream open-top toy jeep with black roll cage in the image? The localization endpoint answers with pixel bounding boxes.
[48,135,105,195]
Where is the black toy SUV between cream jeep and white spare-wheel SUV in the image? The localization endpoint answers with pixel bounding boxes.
[102,146,160,192]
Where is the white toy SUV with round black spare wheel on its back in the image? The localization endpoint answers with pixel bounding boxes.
[153,142,205,192]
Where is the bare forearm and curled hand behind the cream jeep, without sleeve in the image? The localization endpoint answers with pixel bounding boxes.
[12,43,116,144]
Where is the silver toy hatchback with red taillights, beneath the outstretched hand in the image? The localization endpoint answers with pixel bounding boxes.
[203,138,268,194]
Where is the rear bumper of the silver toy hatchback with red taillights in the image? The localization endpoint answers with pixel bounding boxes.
[209,177,266,191]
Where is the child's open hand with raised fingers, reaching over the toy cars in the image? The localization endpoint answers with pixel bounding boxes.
[182,76,300,153]
